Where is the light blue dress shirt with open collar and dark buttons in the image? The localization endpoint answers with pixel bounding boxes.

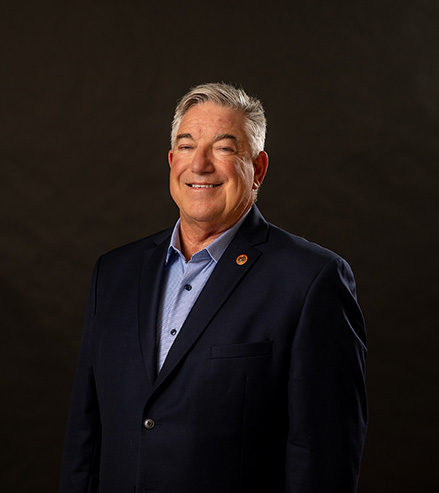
[157,214,247,371]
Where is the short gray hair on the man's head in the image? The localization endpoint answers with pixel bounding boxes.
[171,82,267,158]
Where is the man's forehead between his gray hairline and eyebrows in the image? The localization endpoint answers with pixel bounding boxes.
[178,102,246,138]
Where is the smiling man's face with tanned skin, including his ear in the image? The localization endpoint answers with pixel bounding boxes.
[169,102,268,233]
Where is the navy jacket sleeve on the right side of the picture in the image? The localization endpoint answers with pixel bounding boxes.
[286,258,367,493]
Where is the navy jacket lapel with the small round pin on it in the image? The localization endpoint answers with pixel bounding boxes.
[154,206,268,390]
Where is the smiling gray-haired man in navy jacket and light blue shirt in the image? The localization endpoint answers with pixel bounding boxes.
[60,84,367,493]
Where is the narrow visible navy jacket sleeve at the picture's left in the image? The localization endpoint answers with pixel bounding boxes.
[59,261,101,493]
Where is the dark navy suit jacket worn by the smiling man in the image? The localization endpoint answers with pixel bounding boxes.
[59,207,367,493]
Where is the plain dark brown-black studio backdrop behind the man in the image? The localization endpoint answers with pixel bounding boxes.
[0,0,439,493]
